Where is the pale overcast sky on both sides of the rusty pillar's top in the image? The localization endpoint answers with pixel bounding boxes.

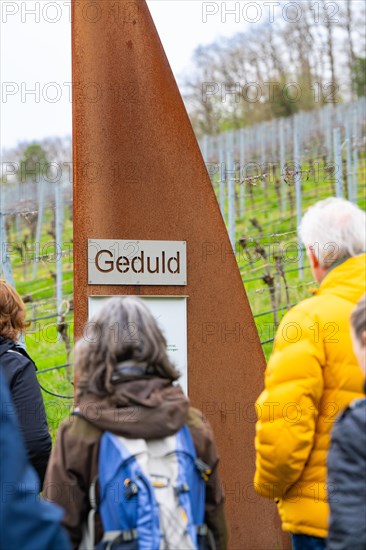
[0,0,258,148]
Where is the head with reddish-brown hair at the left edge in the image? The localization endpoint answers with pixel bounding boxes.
[0,279,27,342]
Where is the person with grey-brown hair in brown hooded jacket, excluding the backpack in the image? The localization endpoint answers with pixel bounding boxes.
[44,297,227,550]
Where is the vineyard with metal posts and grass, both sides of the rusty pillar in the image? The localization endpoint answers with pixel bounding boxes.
[0,99,366,440]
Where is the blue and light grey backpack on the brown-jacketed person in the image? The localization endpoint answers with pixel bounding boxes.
[80,426,215,550]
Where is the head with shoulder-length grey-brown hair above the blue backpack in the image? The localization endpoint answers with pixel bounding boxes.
[75,297,179,395]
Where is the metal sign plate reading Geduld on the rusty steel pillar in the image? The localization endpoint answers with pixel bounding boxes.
[88,239,187,286]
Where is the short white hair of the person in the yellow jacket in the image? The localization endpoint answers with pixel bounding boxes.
[298,197,366,267]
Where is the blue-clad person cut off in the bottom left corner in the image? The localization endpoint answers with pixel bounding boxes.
[0,371,70,550]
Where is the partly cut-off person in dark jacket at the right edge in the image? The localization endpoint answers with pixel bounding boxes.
[327,294,366,550]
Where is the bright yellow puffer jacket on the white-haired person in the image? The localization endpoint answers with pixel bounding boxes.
[254,254,366,538]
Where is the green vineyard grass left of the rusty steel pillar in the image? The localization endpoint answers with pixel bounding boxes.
[9,207,74,438]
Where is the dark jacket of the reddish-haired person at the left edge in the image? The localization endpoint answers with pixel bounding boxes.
[0,336,52,486]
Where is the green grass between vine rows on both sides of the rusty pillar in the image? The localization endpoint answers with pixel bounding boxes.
[5,157,366,437]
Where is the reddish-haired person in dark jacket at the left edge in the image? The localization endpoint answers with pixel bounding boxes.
[0,280,52,486]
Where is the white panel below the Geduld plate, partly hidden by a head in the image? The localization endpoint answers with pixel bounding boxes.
[89,296,188,394]
